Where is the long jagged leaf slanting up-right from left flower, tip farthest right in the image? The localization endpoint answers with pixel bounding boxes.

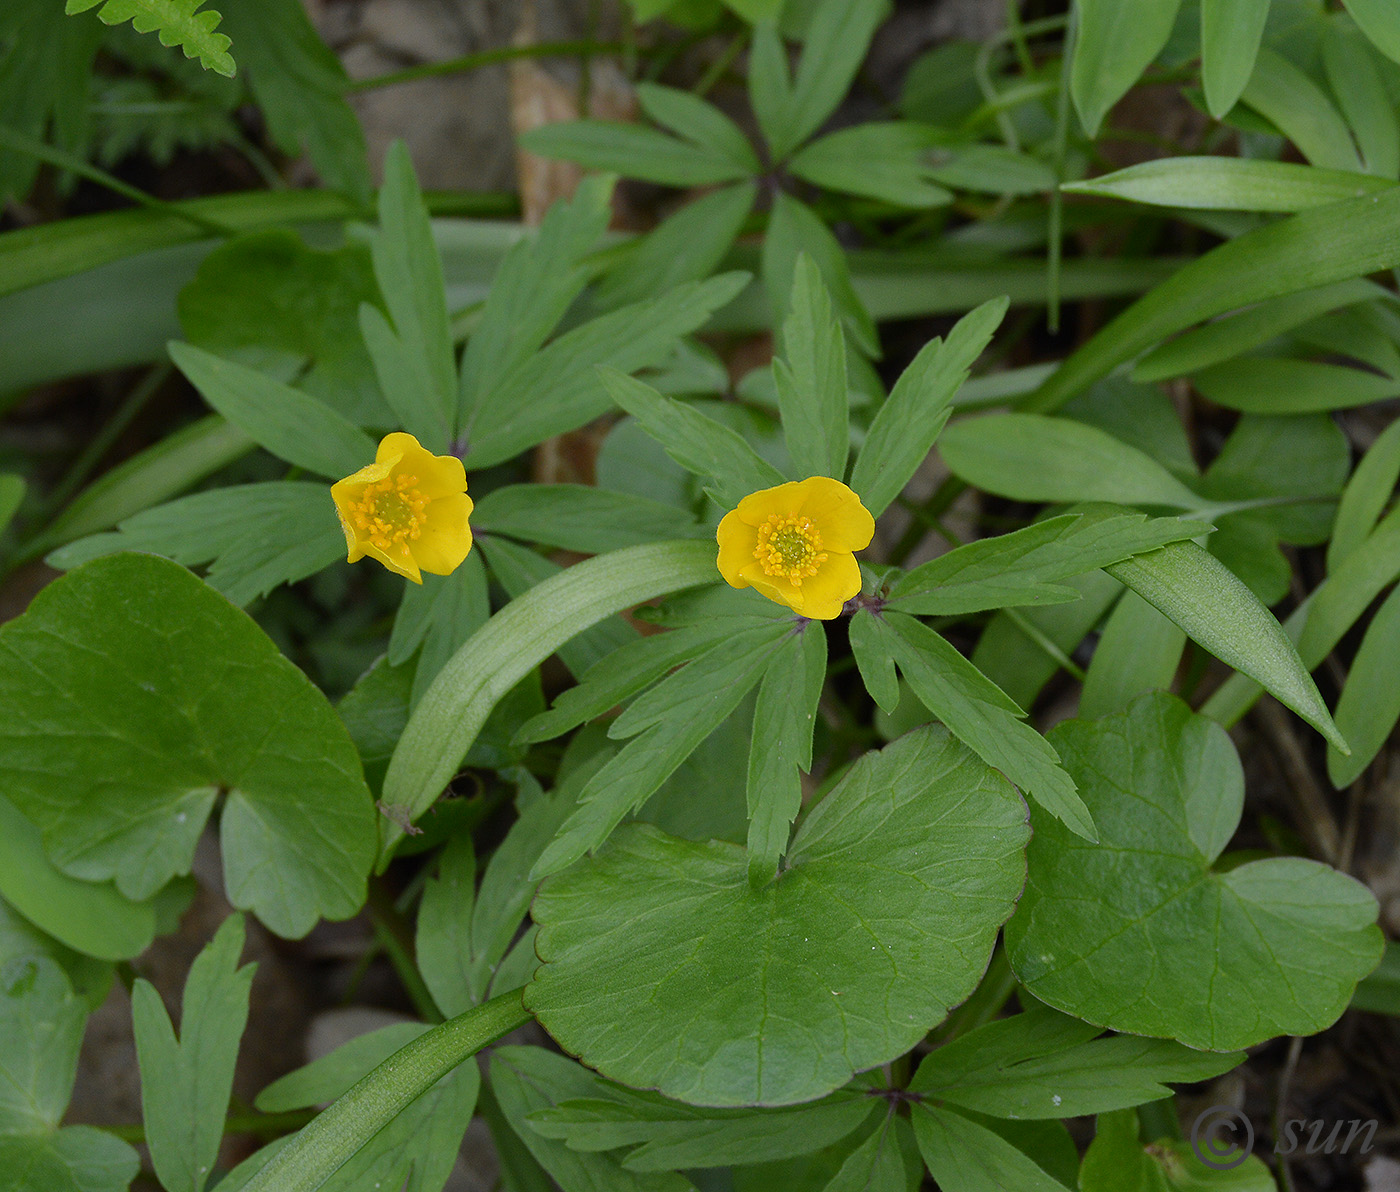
[463,273,748,469]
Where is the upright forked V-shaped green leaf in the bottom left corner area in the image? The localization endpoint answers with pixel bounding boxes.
[132,915,256,1192]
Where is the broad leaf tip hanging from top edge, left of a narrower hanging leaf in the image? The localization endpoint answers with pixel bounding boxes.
[1070,0,1180,137]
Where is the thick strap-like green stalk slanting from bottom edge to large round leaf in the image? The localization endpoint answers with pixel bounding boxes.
[244,989,529,1192]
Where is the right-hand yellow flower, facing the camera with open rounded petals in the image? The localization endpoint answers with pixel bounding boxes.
[715,476,875,621]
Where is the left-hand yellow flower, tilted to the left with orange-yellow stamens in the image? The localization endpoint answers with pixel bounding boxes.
[330,431,472,584]
